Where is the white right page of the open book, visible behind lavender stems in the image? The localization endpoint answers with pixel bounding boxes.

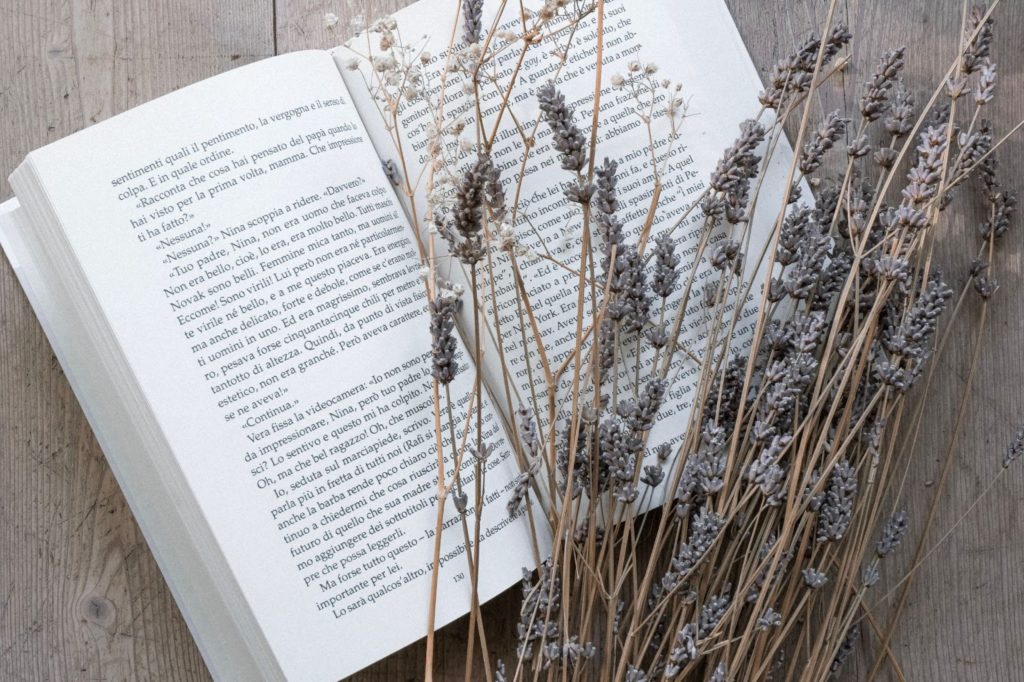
[334,0,790,503]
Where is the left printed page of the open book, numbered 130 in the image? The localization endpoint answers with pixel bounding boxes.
[13,52,532,681]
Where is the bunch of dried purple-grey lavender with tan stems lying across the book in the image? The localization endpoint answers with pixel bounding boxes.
[344,0,1024,682]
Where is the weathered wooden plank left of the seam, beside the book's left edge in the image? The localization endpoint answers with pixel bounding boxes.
[0,0,273,680]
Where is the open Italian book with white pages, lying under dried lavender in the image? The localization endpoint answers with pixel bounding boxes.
[0,0,783,681]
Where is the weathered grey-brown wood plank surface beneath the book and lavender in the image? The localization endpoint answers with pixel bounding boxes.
[0,0,1024,682]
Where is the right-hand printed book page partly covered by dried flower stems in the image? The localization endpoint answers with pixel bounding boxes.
[333,0,798,504]
